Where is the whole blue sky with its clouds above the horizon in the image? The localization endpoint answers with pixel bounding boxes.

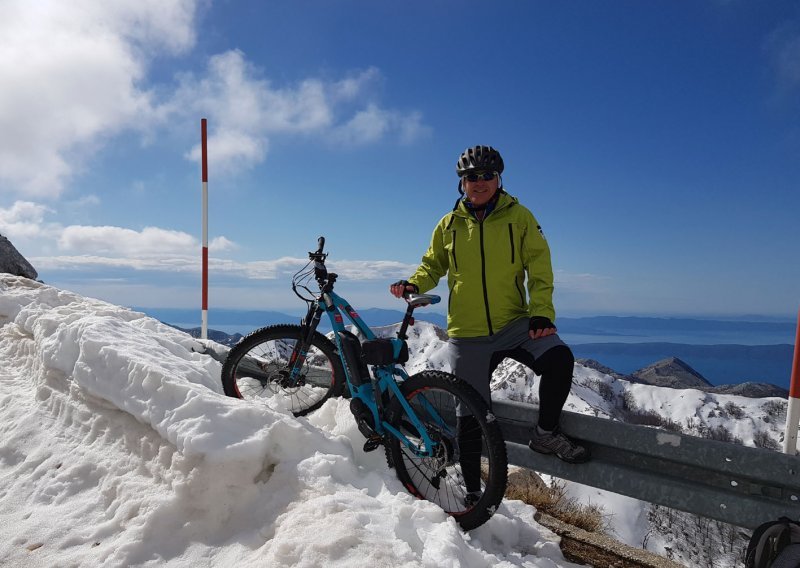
[0,0,800,326]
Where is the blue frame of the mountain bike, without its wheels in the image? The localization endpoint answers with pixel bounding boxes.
[289,286,453,458]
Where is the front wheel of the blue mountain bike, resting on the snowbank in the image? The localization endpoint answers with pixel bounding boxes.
[222,325,344,416]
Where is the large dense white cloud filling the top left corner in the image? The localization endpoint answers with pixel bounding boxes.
[0,0,195,197]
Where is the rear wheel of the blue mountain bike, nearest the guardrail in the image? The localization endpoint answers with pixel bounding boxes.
[387,371,508,530]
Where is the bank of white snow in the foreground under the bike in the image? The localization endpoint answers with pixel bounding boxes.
[0,275,574,568]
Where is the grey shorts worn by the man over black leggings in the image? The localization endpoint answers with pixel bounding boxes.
[448,318,565,416]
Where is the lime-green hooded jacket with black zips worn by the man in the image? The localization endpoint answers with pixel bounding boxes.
[408,192,556,337]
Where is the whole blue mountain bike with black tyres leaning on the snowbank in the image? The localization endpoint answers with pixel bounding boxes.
[222,237,508,530]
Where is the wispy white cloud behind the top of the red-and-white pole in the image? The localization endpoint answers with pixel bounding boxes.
[181,50,429,172]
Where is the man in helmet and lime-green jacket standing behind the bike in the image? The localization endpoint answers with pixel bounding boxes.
[389,146,590,492]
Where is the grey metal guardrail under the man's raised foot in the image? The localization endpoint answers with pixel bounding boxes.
[492,401,800,529]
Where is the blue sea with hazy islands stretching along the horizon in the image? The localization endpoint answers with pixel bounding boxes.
[145,306,794,392]
